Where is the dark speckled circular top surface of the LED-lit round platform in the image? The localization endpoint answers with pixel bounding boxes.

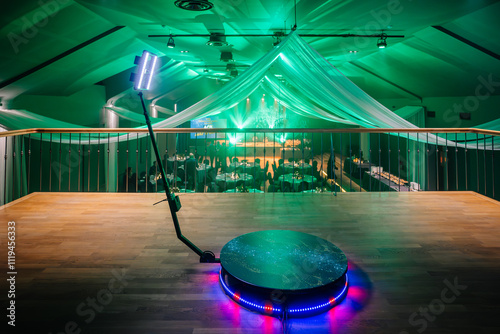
[220,230,347,290]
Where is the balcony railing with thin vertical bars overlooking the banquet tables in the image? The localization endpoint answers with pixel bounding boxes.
[0,128,500,204]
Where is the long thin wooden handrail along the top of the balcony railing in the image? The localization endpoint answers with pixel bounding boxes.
[0,128,500,139]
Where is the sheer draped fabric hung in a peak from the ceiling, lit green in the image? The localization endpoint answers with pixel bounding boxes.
[0,32,498,149]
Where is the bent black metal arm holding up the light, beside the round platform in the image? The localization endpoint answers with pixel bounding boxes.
[139,92,220,263]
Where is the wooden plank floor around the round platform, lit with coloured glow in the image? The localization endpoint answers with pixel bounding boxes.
[0,192,500,334]
